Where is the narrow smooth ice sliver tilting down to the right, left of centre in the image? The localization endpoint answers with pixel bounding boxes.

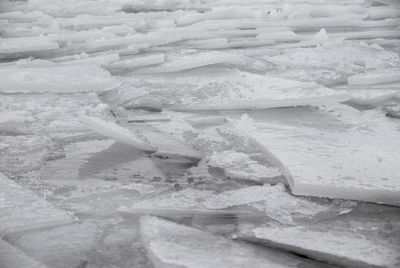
[79,115,157,152]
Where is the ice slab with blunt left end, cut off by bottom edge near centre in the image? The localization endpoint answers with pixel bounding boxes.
[140,217,332,268]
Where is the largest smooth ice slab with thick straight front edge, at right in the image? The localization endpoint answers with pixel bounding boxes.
[238,105,400,206]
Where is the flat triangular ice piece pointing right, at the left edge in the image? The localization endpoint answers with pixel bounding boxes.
[0,173,72,235]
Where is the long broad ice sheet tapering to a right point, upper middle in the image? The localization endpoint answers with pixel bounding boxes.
[125,69,343,111]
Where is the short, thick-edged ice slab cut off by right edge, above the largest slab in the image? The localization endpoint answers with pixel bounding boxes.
[347,69,400,86]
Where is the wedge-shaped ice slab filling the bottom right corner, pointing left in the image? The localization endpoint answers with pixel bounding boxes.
[238,205,400,267]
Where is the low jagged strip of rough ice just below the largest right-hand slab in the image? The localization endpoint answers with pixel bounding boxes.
[120,185,344,225]
